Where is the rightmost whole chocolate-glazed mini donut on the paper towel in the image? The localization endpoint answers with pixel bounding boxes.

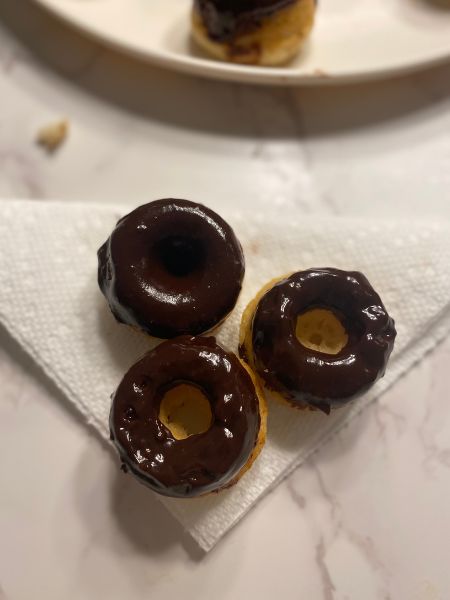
[240,268,396,414]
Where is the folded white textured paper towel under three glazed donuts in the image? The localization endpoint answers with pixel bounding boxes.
[0,201,450,550]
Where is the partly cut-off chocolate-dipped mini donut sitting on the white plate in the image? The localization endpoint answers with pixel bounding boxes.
[192,0,316,66]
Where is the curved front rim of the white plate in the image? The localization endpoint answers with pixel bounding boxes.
[34,0,450,86]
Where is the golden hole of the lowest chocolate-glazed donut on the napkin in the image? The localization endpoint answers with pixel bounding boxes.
[159,383,213,440]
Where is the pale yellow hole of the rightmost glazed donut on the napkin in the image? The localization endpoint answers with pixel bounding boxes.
[295,308,348,354]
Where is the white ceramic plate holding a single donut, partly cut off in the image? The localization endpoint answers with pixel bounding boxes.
[36,0,450,84]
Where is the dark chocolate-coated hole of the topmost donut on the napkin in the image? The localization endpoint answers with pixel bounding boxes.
[155,235,205,277]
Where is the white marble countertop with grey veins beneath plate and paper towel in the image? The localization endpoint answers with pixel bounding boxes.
[0,0,450,600]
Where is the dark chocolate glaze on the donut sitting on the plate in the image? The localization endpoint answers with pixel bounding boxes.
[195,0,296,42]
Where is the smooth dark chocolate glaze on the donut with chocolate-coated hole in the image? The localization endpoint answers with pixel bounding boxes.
[98,199,245,338]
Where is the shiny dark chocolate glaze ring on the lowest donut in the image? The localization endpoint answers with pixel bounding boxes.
[110,336,261,498]
